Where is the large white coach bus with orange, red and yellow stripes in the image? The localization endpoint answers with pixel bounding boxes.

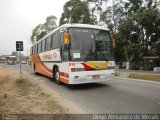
[30,24,115,84]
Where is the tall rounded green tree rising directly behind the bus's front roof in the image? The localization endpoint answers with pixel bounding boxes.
[59,0,94,25]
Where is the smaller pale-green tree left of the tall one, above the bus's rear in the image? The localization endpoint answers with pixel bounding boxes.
[31,15,57,43]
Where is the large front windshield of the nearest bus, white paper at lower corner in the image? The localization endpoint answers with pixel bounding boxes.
[69,28,114,61]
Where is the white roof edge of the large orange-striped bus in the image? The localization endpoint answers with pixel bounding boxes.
[32,23,109,46]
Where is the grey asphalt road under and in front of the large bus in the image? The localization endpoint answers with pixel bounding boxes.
[0,64,160,114]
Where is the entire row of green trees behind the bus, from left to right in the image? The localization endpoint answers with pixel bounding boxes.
[31,0,160,61]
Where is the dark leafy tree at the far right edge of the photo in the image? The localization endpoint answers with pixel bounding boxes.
[135,8,160,55]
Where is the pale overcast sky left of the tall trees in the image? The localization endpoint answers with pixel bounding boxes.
[0,0,68,55]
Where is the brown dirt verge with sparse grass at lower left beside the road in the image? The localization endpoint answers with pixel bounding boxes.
[0,67,66,114]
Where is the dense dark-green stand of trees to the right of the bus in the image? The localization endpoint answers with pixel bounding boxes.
[88,0,160,61]
